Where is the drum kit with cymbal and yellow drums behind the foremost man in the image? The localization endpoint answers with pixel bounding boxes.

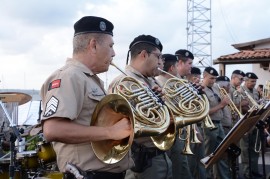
[0,92,63,179]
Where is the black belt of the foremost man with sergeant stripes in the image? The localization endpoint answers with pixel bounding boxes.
[63,171,126,179]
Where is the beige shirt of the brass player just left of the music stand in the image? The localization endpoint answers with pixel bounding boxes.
[204,84,224,121]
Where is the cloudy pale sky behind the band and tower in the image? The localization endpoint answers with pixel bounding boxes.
[0,0,270,89]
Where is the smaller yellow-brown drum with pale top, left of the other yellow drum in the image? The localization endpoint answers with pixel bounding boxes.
[17,150,39,170]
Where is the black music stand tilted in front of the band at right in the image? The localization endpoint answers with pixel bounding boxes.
[201,102,270,178]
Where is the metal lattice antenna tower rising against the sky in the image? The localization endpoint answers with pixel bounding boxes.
[186,0,213,67]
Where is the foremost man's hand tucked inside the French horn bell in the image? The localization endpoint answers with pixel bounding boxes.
[110,118,133,140]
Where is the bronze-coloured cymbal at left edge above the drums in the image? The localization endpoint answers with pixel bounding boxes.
[0,92,32,105]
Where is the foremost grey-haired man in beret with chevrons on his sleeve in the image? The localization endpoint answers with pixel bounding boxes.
[41,16,133,179]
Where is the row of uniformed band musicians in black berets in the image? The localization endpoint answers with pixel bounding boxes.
[0,16,269,179]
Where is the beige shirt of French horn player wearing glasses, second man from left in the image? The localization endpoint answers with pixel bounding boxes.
[109,65,156,147]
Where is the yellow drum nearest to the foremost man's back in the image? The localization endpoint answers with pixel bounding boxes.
[37,141,56,165]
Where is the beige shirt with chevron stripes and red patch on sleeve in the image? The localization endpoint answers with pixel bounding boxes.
[41,59,133,173]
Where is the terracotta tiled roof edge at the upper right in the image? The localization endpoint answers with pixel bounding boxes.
[214,48,270,64]
